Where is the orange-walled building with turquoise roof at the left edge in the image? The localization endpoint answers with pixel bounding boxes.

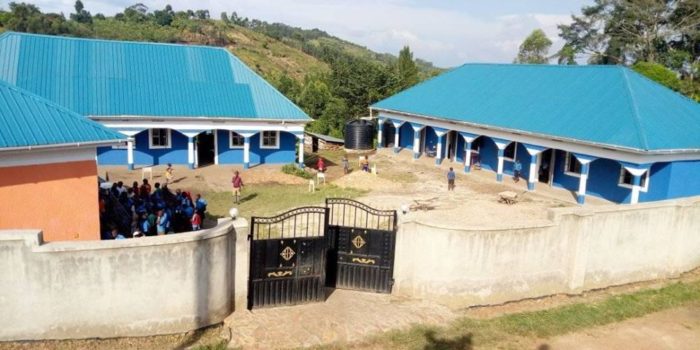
[0,81,126,241]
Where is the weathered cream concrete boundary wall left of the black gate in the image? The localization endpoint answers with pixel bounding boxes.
[0,219,247,340]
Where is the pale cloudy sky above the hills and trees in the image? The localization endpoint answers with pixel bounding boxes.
[8,0,593,67]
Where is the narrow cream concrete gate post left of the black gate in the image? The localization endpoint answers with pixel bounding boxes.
[233,217,250,312]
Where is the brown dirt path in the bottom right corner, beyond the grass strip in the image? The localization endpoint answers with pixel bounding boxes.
[533,304,700,350]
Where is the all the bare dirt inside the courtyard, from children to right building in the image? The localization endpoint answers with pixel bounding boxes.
[99,149,608,228]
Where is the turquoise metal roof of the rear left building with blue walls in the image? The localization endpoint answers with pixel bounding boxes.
[0,32,309,120]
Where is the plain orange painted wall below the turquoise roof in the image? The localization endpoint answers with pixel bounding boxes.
[0,160,100,241]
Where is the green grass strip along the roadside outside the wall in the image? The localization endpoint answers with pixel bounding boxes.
[325,281,700,349]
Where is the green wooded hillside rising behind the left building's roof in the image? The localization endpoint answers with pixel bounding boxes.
[0,1,440,137]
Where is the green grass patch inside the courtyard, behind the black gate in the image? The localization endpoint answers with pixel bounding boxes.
[207,184,365,218]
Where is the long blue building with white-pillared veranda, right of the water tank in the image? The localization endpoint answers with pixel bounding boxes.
[370,64,700,204]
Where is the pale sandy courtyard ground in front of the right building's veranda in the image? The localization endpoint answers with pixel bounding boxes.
[334,149,606,228]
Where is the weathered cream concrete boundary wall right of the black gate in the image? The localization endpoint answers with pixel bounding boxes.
[394,197,700,306]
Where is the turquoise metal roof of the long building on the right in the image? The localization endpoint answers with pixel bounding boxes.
[372,64,700,151]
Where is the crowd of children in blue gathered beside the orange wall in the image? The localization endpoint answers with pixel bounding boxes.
[100,178,207,239]
